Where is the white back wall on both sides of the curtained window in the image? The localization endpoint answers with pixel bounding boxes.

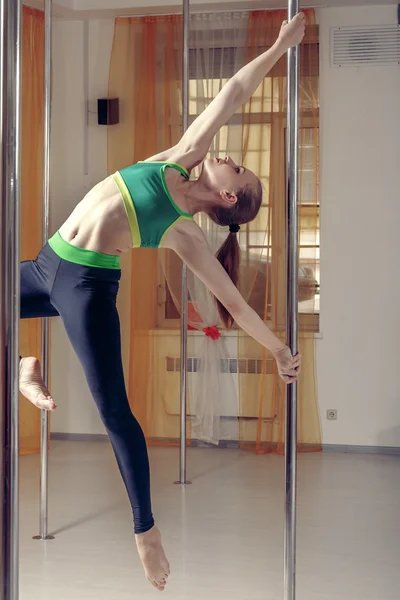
[52,6,400,446]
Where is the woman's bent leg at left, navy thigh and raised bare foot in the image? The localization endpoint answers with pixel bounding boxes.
[19,258,58,410]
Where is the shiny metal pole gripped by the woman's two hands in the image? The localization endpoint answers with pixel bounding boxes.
[284,0,300,600]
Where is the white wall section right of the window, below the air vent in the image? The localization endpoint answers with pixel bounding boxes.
[317,6,400,446]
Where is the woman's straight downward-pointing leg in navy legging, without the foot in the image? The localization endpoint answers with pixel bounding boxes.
[58,289,154,533]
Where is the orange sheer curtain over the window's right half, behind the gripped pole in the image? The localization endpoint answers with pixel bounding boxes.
[238,10,321,453]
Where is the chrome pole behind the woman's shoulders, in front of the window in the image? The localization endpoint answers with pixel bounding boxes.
[175,0,190,485]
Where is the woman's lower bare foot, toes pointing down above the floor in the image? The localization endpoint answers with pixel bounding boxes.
[135,526,170,592]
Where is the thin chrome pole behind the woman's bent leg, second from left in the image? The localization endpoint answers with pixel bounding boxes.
[34,0,54,540]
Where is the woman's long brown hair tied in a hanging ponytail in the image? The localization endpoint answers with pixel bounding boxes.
[209,181,262,329]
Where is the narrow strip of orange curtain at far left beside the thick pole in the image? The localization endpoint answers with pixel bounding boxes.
[20,6,44,454]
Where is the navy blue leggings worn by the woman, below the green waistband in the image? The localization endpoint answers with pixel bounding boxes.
[21,245,154,533]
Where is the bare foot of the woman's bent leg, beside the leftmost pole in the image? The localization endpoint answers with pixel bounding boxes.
[19,357,57,410]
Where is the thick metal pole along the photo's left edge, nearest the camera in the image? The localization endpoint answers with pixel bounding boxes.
[0,0,22,600]
